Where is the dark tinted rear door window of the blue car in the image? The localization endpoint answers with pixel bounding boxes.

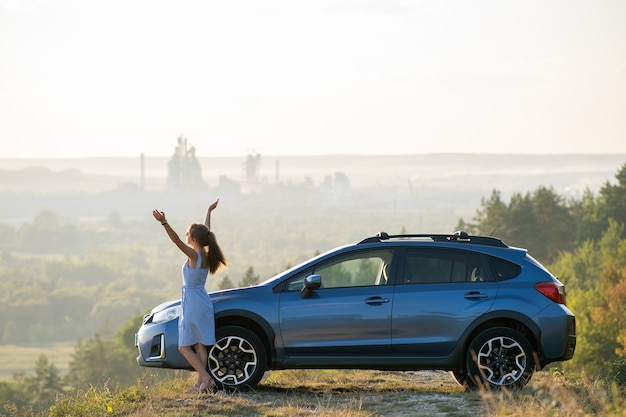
[401,248,493,284]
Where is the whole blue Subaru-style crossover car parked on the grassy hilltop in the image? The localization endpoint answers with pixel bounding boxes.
[135,231,576,390]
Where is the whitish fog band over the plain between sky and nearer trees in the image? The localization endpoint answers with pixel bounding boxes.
[0,154,626,232]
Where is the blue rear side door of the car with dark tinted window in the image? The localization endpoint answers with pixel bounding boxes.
[391,248,498,357]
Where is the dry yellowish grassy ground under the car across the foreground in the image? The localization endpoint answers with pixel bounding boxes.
[2,370,626,417]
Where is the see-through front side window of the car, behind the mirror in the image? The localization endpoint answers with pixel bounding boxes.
[287,250,392,291]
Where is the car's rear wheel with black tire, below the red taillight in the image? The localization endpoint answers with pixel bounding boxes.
[466,327,535,390]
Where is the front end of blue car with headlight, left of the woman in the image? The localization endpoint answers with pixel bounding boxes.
[135,319,192,369]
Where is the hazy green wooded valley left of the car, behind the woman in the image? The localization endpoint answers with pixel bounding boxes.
[0,211,266,344]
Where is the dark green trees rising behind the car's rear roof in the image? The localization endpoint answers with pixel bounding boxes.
[457,164,626,263]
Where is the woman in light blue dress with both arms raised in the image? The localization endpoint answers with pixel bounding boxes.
[152,199,227,392]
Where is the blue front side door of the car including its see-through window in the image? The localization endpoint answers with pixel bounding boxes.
[279,250,393,357]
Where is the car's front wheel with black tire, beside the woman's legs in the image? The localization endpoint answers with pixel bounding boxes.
[207,326,267,390]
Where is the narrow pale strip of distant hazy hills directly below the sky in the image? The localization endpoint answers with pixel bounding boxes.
[0,153,626,182]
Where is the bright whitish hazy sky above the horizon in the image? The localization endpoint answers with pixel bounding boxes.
[0,0,626,158]
